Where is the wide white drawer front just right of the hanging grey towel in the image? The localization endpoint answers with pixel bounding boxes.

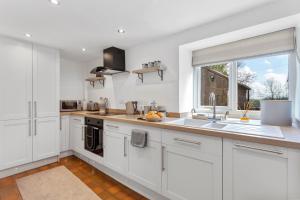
[162,130,222,156]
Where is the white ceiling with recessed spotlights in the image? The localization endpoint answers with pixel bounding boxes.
[0,0,276,61]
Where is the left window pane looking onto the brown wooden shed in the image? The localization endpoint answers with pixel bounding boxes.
[200,63,229,106]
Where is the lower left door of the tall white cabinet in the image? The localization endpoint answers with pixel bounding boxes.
[0,120,32,170]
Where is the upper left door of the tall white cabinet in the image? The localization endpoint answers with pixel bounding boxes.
[0,37,32,120]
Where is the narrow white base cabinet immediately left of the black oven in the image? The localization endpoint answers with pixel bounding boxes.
[70,116,85,154]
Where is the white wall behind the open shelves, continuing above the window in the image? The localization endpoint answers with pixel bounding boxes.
[86,0,300,112]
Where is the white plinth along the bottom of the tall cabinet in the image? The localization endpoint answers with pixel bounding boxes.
[0,156,59,178]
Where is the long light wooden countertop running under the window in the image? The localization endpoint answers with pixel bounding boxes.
[61,111,300,149]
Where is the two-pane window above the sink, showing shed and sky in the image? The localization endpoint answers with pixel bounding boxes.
[194,53,290,111]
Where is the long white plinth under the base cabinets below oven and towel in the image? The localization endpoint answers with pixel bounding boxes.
[74,152,168,200]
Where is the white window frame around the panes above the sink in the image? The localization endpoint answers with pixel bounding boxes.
[194,52,296,119]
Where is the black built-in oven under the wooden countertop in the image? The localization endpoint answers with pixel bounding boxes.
[84,117,103,157]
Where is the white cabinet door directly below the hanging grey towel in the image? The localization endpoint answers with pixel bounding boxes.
[128,137,162,192]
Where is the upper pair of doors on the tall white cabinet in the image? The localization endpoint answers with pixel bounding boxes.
[0,37,59,120]
